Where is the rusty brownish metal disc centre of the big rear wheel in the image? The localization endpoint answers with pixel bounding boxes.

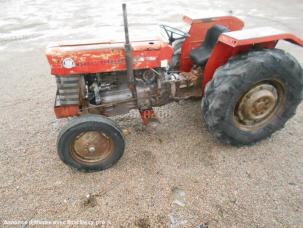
[234,81,285,129]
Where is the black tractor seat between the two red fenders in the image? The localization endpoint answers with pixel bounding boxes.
[190,25,230,66]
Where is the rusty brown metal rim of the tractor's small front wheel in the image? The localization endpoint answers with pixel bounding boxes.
[71,131,114,165]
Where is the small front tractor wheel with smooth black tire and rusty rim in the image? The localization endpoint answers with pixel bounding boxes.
[57,115,125,172]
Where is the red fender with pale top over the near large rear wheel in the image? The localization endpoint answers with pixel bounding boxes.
[202,27,303,94]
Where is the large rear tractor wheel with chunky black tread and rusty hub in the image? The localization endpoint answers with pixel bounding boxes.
[202,49,303,145]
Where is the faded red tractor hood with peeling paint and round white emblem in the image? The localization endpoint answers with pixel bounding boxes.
[46,39,173,76]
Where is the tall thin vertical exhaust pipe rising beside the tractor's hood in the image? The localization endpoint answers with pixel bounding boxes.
[122,3,137,99]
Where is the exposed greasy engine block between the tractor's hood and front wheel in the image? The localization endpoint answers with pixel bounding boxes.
[83,68,201,116]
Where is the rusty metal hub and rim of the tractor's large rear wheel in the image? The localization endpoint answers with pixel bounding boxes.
[235,83,279,126]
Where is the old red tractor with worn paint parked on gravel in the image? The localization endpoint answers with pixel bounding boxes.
[46,4,303,172]
